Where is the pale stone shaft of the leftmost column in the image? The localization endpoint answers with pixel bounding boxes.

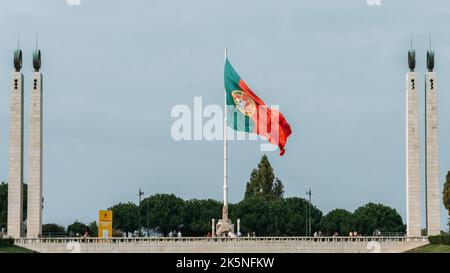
[8,70,23,238]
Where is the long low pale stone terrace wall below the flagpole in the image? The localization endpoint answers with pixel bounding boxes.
[15,237,428,253]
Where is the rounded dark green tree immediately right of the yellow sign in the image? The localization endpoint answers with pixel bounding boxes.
[108,202,139,233]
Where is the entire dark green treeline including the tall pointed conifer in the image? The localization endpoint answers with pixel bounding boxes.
[0,156,406,236]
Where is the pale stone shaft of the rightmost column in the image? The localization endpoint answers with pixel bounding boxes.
[425,71,441,235]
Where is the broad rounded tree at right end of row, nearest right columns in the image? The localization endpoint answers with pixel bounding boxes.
[353,203,406,236]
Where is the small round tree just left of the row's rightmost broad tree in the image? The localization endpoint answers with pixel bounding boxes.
[320,209,354,236]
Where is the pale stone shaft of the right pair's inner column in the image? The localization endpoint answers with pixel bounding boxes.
[406,72,422,236]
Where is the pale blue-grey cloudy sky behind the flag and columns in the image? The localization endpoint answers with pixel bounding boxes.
[0,0,450,227]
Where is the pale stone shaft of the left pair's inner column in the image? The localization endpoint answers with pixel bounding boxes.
[27,72,42,237]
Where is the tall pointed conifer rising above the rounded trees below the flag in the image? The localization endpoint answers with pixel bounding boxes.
[244,155,284,200]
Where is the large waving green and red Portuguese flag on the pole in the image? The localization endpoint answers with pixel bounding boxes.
[225,58,291,155]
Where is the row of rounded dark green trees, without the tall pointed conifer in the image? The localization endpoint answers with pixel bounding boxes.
[103,194,406,236]
